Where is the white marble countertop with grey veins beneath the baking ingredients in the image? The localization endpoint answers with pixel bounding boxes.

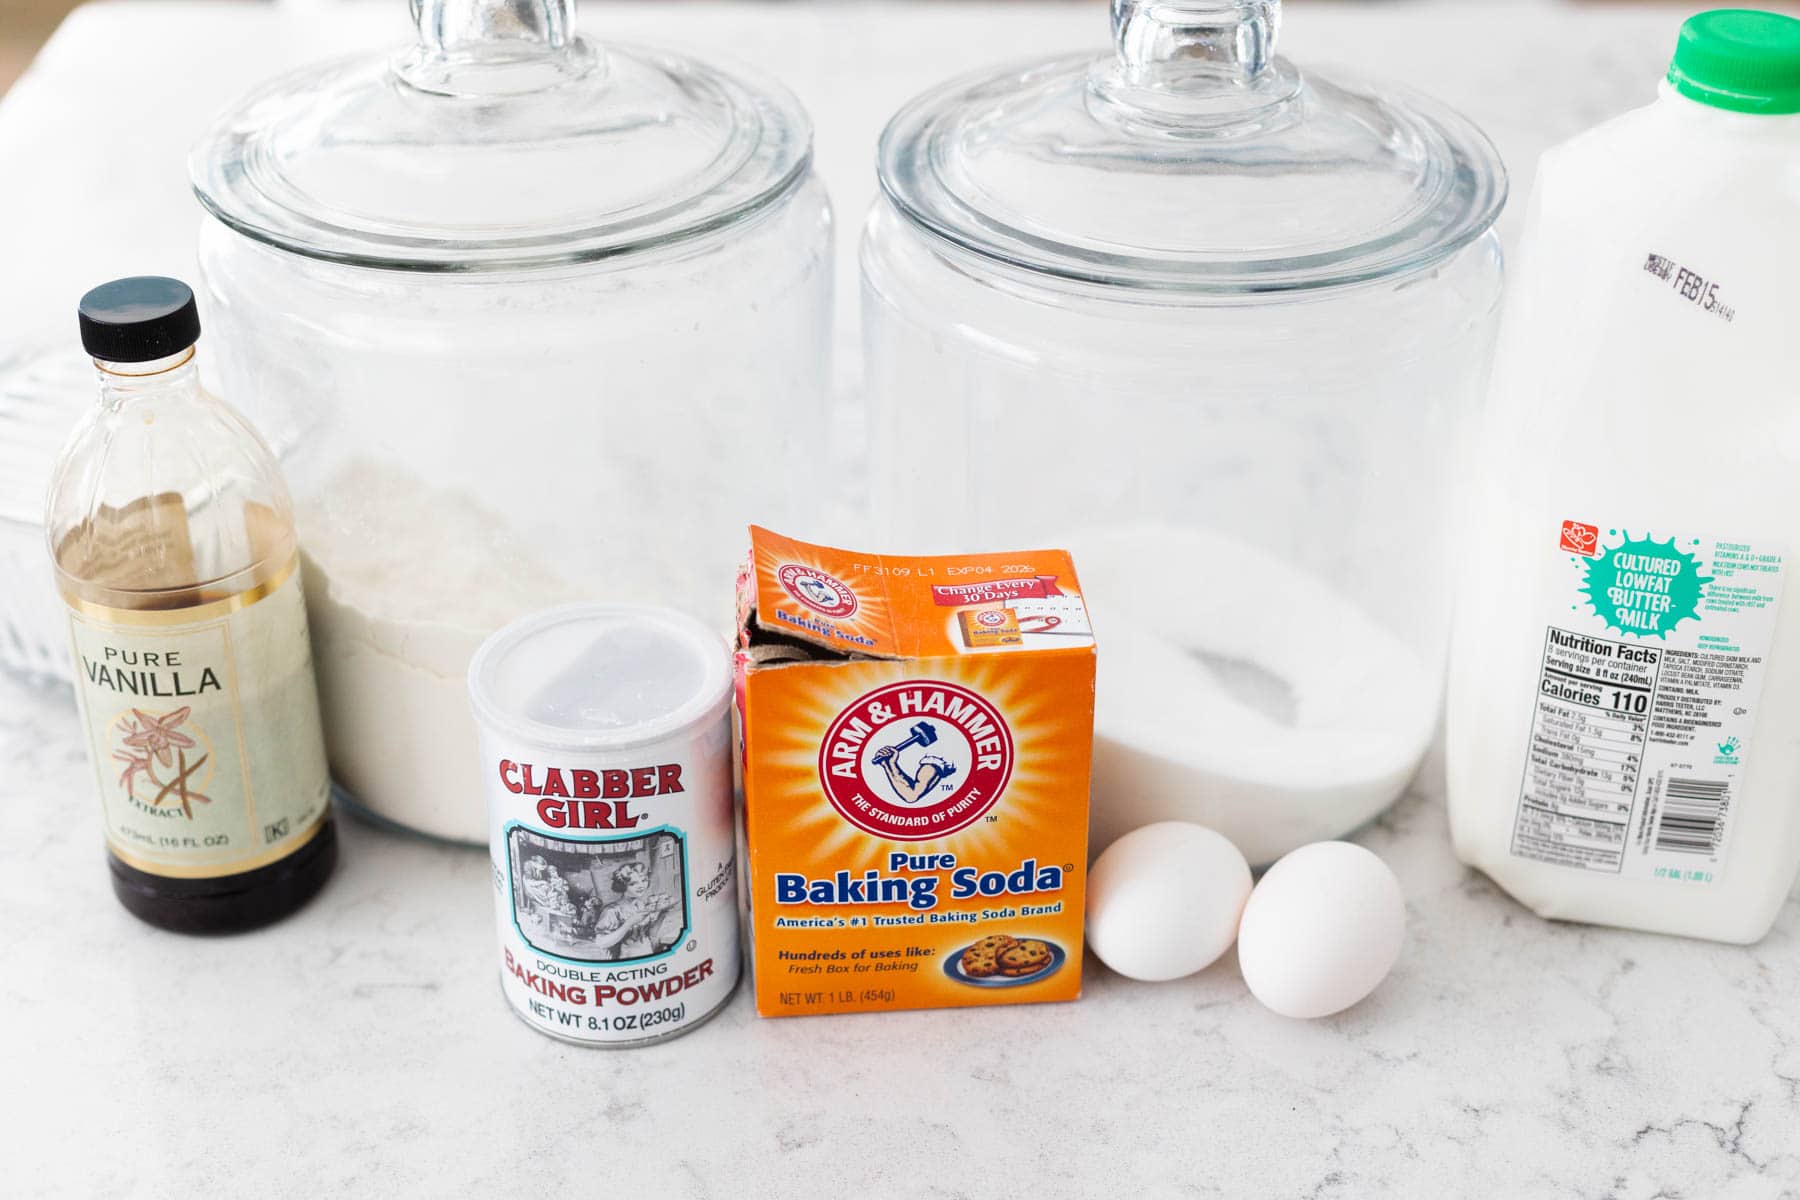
[0,2,1800,1198]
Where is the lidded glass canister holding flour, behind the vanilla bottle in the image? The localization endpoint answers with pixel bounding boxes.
[191,0,832,842]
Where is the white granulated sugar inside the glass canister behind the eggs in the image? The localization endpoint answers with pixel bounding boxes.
[1071,525,1442,864]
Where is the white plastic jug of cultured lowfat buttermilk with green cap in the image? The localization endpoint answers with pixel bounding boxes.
[1449,13,1800,943]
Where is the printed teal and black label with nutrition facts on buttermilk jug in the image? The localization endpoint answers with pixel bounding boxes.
[1512,522,1782,883]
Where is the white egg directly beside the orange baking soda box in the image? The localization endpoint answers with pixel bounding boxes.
[1087,820,1249,981]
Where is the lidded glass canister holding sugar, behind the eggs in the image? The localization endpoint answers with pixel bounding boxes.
[862,0,1507,862]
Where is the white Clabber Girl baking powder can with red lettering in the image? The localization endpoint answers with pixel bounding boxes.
[468,604,740,1045]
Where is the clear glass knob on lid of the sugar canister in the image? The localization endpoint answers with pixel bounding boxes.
[1093,0,1300,137]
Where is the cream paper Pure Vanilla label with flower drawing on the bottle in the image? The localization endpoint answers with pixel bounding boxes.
[68,561,331,878]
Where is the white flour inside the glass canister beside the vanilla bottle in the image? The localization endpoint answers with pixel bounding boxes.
[301,459,578,842]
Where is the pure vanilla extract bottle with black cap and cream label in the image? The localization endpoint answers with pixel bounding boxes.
[45,277,337,932]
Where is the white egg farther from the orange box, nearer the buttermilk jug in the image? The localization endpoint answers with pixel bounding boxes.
[1238,842,1406,1016]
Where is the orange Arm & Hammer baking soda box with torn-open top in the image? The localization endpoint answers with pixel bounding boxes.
[736,527,1094,1016]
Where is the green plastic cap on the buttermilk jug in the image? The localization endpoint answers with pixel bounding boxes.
[1669,9,1800,113]
